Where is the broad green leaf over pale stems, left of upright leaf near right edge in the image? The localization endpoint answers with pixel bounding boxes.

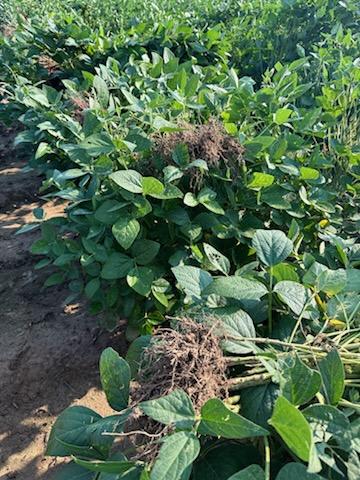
[280,355,321,405]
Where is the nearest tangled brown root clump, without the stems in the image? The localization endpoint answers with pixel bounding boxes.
[127,318,228,462]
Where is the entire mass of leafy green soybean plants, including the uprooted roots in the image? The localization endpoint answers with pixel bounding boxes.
[0,0,360,480]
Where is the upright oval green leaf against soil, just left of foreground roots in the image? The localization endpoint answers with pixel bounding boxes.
[100,347,131,411]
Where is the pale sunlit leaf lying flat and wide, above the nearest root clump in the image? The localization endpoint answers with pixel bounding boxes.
[203,276,268,300]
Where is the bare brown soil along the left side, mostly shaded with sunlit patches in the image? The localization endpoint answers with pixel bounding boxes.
[0,126,126,480]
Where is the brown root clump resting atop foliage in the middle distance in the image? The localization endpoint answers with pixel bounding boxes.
[154,118,244,189]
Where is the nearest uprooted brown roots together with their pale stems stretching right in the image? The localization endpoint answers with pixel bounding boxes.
[115,317,360,463]
